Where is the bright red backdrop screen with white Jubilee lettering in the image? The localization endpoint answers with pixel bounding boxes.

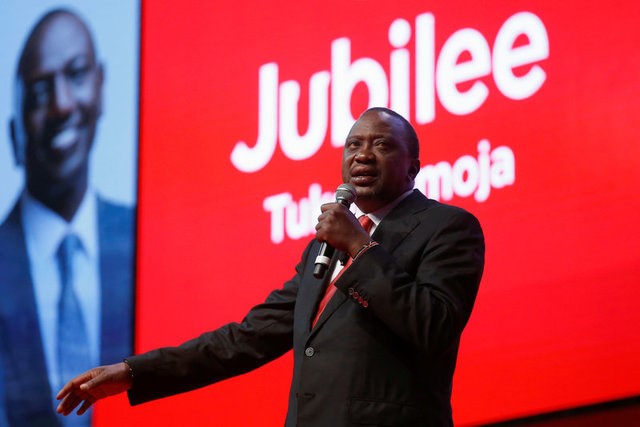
[96,0,640,427]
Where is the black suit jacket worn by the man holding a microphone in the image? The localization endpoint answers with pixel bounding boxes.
[129,190,484,427]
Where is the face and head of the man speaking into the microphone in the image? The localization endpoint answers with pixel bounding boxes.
[342,111,420,212]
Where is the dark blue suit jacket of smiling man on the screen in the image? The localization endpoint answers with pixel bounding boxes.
[0,198,135,427]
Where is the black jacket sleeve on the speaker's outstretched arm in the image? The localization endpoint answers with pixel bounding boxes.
[127,247,309,405]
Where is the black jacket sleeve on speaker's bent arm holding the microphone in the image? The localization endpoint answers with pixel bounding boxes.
[336,201,484,357]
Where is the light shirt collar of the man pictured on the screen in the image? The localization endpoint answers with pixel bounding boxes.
[21,189,97,257]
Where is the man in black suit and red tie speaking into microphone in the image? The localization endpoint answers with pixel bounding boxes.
[58,108,484,427]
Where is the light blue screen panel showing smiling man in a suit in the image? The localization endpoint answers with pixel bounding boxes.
[0,1,139,427]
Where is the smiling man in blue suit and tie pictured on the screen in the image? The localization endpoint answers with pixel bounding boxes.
[0,9,135,427]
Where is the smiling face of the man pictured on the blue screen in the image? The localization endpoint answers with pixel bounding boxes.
[12,14,102,189]
